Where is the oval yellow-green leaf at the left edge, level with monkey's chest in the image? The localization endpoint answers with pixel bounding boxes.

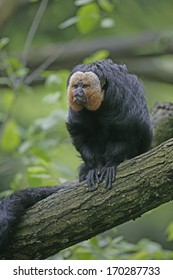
[0,120,21,152]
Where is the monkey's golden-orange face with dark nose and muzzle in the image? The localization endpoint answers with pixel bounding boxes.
[67,71,103,111]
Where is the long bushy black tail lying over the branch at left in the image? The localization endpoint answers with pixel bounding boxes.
[0,186,62,252]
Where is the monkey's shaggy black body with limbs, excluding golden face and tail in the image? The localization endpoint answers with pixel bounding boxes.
[67,59,152,190]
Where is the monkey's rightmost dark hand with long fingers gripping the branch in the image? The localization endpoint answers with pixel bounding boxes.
[100,166,116,189]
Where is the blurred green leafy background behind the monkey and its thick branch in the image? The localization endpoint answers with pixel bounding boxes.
[0,0,173,259]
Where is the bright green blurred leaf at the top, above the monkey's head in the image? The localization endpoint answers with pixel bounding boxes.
[77,3,101,34]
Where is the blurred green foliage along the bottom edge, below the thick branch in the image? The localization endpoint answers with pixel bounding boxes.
[57,233,173,260]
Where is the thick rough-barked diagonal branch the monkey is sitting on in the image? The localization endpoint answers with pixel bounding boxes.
[0,104,173,259]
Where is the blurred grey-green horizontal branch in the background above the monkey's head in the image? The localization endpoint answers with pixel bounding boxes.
[23,31,173,83]
